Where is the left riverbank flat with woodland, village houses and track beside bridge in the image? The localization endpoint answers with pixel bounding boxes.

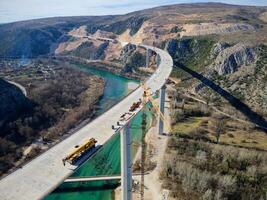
[0,59,105,178]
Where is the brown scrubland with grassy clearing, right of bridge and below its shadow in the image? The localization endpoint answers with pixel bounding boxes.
[164,85,267,200]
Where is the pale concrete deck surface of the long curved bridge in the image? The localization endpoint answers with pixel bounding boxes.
[0,39,173,200]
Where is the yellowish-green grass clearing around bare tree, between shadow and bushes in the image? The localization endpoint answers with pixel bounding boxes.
[172,92,267,151]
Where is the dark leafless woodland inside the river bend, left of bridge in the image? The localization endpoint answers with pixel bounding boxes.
[0,61,104,175]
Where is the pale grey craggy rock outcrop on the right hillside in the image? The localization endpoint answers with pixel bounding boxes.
[213,44,257,75]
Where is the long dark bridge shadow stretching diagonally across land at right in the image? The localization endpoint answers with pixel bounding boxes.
[175,62,267,133]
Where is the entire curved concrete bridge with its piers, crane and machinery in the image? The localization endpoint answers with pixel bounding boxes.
[0,38,173,200]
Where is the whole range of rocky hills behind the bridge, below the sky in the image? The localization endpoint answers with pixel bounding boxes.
[0,3,267,122]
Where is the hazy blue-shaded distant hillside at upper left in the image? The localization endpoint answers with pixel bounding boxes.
[0,16,113,58]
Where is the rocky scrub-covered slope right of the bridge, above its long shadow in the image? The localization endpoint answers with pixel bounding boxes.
[166,36,267,122]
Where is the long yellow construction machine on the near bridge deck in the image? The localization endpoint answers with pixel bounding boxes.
[62,138,97,165]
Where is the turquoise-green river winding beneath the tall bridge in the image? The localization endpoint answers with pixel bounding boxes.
[45,65,152,200]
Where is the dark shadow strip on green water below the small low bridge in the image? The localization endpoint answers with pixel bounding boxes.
[53,181,120,193]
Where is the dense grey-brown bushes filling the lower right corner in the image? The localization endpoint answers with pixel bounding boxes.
[161,136,267,200]
